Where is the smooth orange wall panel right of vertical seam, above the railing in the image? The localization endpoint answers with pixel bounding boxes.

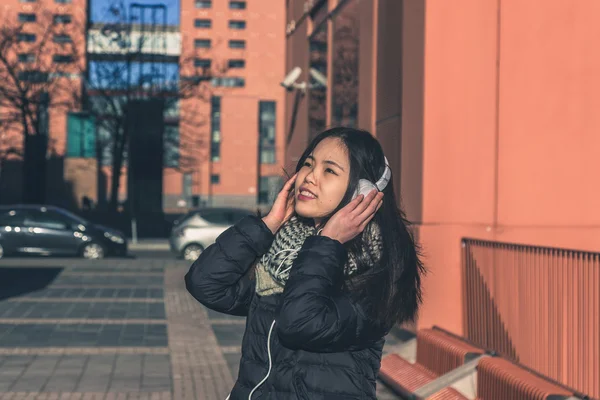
[498,0,600,251]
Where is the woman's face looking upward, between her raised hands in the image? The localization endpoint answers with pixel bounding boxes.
[294,138,350,224]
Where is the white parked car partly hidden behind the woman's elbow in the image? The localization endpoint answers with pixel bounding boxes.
[169,207,253,261]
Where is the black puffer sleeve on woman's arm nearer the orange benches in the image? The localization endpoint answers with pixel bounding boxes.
[275,236,381,352]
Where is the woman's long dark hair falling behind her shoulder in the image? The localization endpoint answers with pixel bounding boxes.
[296,127,425,330]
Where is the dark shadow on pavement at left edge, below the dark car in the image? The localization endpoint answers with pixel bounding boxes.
[0,267,63,301]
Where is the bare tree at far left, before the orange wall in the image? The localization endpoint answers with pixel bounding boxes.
[0,9,81,202]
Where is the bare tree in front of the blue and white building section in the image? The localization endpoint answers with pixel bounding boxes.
[85,10,226,211]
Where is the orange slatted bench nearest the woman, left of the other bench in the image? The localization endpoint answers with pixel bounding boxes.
[379,329,484,400]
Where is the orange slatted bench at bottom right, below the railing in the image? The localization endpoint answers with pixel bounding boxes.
[477,357,574,400]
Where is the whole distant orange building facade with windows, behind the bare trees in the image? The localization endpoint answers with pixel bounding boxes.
[0,0,285,211]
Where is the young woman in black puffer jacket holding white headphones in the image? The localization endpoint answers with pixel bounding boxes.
[185,128,423,400]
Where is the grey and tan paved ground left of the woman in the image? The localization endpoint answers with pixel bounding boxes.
[0,259,404,400]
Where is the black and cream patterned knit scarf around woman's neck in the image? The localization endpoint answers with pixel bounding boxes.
[256,216,383,296]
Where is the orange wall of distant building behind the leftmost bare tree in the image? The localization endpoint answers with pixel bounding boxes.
[0,0,86,207]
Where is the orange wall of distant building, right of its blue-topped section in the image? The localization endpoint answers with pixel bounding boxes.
[178,0,285,206]
